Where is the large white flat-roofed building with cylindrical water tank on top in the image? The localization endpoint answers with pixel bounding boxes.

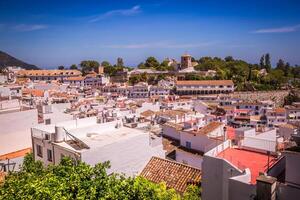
[31,117,165,176]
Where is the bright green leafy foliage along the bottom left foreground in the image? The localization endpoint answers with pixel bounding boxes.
[0,154,200,200]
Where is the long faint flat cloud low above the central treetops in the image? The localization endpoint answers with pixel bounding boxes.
[102,42,216,49]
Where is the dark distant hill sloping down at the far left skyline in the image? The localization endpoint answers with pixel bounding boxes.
[0,51,39,69]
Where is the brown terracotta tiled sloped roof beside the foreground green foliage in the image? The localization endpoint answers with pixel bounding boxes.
[140,157,201,193]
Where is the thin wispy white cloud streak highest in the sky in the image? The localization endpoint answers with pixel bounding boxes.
[89,5,142,22]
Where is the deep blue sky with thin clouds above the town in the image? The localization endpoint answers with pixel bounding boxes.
[0,0,300,67]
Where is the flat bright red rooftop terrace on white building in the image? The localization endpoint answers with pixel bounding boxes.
[217,148,276,184]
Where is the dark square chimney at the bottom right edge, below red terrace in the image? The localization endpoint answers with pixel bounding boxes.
[256,174,277,200]
